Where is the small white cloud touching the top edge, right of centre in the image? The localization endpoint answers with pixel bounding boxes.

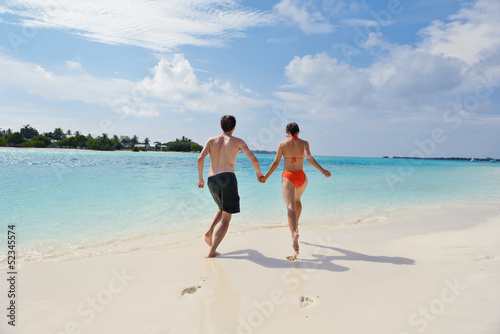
[274,0,334,34]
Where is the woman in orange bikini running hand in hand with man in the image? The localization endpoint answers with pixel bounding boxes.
[264,123,331,254]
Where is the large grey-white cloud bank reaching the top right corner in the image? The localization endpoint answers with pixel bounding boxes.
[275,0,500,121]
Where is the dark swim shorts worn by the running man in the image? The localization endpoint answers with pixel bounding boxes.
[207,173,240,213]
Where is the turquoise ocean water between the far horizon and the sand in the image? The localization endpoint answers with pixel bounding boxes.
[0,148,500,267]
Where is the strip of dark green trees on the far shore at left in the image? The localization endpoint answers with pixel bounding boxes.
[0,125,203,152]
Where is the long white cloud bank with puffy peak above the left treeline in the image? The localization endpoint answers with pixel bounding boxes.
[0,54,266,116]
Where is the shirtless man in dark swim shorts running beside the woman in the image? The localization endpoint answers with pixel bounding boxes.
[198,115,263,257]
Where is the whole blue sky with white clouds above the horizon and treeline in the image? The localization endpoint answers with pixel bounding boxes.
[0,0,500,158]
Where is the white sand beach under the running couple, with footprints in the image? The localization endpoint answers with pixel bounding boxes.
[0,204,500,334]
